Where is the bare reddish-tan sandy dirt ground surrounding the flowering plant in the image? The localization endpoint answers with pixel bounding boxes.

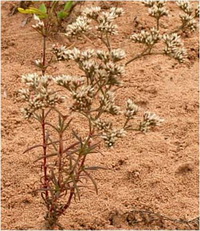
[2,2,199,230]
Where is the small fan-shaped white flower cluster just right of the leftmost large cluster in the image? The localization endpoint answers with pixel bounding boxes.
[54,75,85,91]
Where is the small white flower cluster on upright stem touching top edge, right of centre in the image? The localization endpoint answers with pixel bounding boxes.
[149,1,169,19]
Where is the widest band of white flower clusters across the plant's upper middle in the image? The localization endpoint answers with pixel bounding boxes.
[53,46,126,85]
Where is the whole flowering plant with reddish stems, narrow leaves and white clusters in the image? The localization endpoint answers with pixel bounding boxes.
[19,1,194,229]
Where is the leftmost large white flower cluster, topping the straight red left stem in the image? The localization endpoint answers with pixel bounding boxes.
[19,73,64,118]
